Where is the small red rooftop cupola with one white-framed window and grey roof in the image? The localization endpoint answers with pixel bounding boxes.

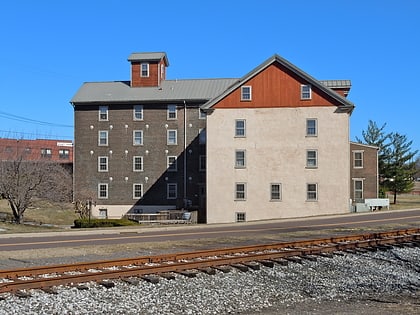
[128,52,169,87]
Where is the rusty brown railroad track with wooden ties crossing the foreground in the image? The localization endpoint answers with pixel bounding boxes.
[0,229,420,294]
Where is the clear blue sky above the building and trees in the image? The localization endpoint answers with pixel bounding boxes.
[0,0,420,154]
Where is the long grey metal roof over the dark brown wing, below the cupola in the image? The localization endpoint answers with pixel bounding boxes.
[70,79,238,105]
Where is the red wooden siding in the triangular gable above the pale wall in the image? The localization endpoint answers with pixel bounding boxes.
[214,64,339,108]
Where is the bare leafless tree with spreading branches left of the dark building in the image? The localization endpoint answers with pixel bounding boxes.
[0,158,72,224]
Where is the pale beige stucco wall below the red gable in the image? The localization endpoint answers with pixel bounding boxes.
[207,106,350,223]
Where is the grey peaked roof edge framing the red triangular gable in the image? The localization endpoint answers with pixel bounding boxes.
[201,54,354,113]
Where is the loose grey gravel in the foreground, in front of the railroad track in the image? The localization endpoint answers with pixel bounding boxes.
[0,247,420,315]
